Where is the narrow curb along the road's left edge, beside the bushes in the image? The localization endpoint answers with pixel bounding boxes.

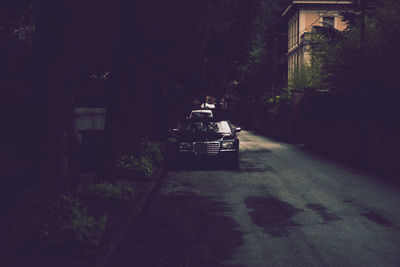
[93,170,166,267]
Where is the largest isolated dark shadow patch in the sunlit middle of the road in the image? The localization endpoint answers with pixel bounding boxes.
[245,196,302,237]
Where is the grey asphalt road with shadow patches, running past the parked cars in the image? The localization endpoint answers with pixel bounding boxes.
[109,131,400,267]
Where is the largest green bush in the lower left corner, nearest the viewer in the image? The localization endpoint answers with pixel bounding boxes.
[10,195,107,257]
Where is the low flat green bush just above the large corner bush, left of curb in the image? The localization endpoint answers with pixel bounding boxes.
[77,182,135,202]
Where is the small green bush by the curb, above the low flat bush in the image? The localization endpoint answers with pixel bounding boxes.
[117,155,154,178]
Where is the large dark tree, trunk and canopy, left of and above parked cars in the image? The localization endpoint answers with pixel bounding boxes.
[99,0,272,180]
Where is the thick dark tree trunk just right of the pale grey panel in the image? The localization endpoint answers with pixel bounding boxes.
[100,0,150,180]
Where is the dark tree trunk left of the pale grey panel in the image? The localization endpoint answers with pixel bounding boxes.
[34,0,72,195]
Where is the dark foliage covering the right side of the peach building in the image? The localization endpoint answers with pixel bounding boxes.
[304,0,400,100]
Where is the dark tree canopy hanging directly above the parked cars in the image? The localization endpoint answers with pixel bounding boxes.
[136,0,274,105]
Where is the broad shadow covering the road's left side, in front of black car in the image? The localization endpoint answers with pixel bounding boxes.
[109,192,243,267]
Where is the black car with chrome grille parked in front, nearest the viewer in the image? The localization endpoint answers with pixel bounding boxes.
[170,118,241,168]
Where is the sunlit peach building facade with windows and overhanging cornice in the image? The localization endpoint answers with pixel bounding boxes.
[282,0,353,80]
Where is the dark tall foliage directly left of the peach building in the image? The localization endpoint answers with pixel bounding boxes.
[237,0,289,100]
